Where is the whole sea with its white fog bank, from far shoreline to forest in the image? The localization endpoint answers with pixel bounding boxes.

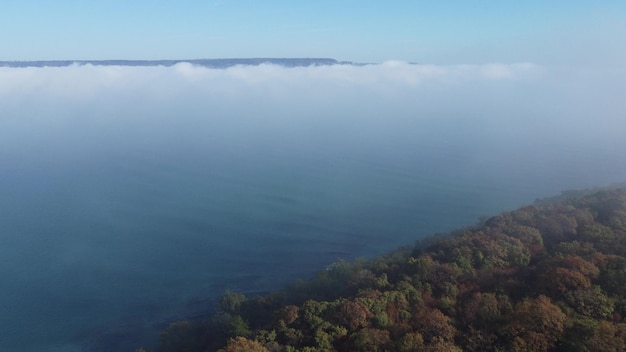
[0,62,626,351]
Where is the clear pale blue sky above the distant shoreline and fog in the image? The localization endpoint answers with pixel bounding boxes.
[0,0,626,65]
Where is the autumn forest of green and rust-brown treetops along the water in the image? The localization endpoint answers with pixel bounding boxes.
[135,189,626,352]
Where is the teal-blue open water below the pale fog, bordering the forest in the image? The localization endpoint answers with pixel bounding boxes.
[0,117,610,351]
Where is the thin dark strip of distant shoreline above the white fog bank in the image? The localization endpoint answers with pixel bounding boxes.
[0,58,362,68]
